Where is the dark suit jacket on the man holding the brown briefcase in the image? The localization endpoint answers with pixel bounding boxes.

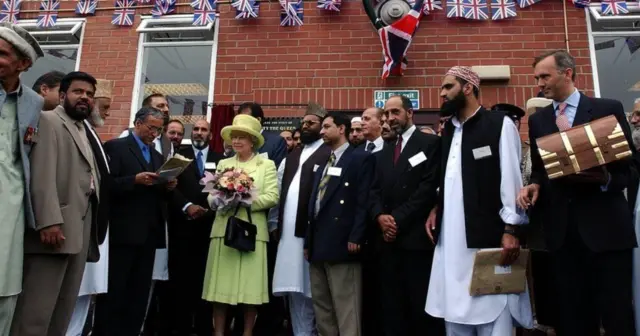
[529,94,636,252]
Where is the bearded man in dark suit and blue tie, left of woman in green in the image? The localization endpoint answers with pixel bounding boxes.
[165,120,223,336]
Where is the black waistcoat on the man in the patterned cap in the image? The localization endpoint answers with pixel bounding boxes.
[436,107,505,248]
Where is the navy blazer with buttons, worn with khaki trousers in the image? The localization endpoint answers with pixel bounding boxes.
[305,146,374,262]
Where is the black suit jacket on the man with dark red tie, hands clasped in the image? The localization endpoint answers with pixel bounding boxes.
[370,129,441,250]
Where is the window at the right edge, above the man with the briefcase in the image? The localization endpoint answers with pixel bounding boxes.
[587,2,640,112]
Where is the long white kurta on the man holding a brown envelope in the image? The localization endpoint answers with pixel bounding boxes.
[425,113,533,327]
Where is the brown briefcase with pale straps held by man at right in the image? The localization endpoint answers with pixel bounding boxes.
[536,115,631,179]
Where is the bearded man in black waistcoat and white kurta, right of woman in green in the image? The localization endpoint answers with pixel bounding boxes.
[273,104,331,336]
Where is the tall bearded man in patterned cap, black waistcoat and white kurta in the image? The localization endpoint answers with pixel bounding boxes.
[425,66,533,336]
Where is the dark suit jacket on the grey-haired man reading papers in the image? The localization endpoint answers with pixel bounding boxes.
[104,134,185,247]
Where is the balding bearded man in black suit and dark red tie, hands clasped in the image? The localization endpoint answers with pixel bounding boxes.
[370,96,444,336]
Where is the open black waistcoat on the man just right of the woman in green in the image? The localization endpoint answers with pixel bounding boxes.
[278,144,331,238]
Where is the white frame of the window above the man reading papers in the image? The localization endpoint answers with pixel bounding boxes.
[129,14,220,145]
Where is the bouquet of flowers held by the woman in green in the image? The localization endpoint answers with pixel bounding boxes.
[200,167,256,212]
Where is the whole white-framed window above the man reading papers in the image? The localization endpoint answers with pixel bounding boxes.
[131,15,218,144]
